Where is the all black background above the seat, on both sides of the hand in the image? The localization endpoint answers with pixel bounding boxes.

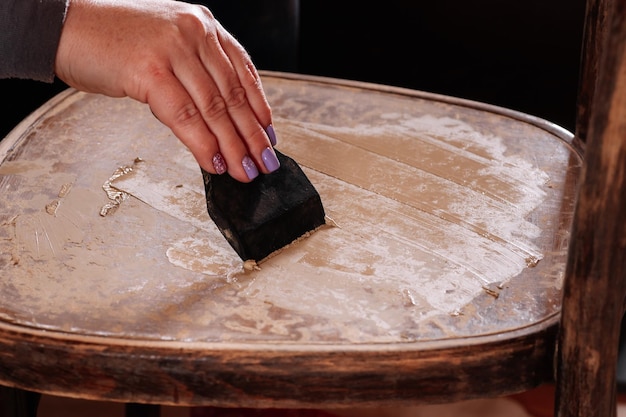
[0,0,584,137]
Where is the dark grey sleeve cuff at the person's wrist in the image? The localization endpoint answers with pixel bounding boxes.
[0,0,69,82]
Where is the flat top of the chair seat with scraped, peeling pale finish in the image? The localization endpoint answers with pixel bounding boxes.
[0,77,580,344]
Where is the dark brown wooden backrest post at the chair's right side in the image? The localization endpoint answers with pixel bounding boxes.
[556,0,626,416]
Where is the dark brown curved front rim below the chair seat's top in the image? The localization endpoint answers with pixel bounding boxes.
[0,325,556,408]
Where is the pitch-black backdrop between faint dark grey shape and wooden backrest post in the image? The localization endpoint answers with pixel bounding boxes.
[300,0,585,130]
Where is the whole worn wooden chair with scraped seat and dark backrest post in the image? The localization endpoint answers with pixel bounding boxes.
[0,0,626,417]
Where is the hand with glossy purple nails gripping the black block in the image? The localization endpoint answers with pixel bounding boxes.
[55,0,278,182]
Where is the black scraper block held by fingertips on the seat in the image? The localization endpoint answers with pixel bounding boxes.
[202,150,325,261]
